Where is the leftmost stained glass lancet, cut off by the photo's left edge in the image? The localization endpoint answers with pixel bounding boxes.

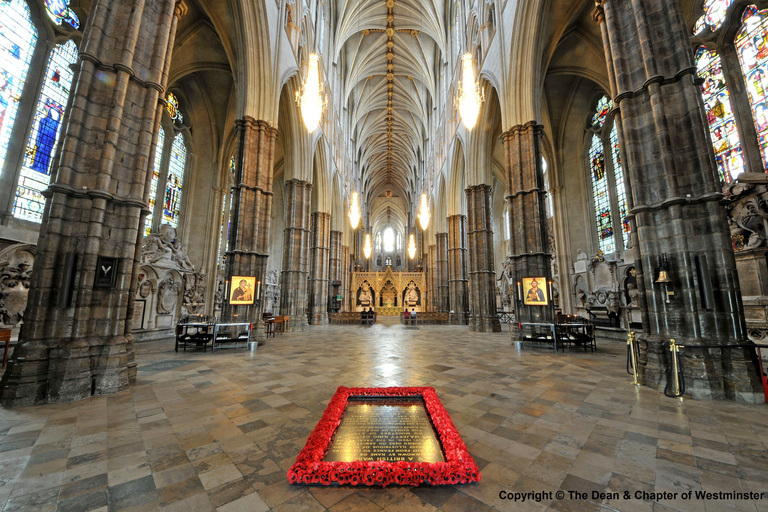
[0,0,37,180]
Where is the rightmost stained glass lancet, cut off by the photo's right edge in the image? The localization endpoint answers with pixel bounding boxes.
[736,5,768,168]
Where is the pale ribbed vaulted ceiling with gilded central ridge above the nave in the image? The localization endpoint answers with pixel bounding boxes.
[334,0,446,234]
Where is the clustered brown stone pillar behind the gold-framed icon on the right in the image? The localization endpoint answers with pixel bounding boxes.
[501,121,554,322]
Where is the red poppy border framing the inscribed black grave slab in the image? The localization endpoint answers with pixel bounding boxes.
[288,386,480,487]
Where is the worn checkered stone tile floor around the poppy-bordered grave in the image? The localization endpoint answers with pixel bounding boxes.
[0,323,768,512]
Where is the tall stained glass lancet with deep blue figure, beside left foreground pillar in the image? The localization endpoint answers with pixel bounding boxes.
[13,41,77,222]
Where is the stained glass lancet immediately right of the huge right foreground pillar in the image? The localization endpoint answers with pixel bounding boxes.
[696,46,744,183]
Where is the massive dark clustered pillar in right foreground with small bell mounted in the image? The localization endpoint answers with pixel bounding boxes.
[594,0,763,403]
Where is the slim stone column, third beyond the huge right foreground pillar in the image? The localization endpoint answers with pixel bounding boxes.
[448,215,468,324]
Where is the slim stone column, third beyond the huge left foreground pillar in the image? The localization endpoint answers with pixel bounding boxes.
[309,212,331,325]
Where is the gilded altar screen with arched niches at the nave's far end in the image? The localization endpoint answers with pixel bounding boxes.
[349,267,427,316]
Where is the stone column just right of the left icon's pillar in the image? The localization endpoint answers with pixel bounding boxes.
[280,180,312,331]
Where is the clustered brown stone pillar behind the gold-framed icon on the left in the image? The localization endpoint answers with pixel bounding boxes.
[221,116,277,324]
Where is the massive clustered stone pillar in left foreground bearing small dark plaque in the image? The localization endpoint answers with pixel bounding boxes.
[0,0,185,407]
